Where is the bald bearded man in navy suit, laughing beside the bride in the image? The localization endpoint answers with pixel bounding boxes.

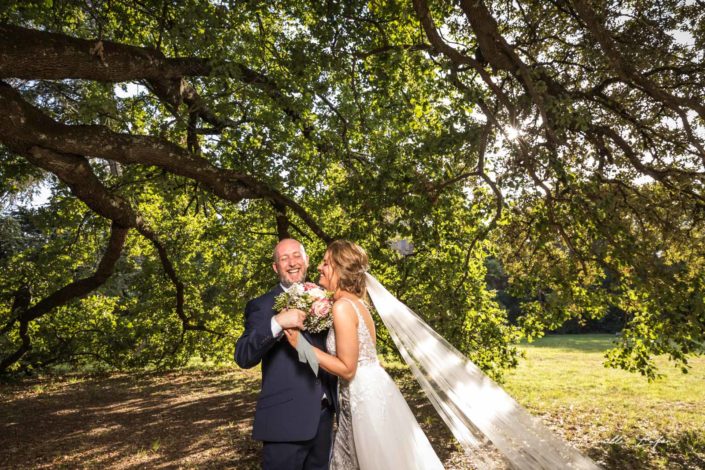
[235,239,336,470]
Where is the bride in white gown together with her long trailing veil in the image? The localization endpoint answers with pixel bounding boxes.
[285,240,599,470]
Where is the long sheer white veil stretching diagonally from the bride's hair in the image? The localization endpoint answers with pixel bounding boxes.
[367,273,599,470]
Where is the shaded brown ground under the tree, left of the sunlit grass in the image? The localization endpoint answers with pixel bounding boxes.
[0,369,500,469]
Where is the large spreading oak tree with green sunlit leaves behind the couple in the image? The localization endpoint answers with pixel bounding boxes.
[0,0,705,376]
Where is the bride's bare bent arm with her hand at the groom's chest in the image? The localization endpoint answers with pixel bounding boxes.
[284,302,360,380]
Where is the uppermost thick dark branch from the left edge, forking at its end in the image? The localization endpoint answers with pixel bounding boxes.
[0,24,312,136]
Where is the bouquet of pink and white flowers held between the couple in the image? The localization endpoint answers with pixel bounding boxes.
[274,282,333,333]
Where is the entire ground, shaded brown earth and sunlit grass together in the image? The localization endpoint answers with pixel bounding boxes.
[0,335,705,470]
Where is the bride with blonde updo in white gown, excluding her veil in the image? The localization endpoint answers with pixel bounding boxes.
[285,240,443,470]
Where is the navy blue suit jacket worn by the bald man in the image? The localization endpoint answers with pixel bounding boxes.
[235,284,337,442]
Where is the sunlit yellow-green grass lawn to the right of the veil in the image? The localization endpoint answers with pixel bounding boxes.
[505,335,705,469]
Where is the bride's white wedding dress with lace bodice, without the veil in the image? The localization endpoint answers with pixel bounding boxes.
[326,299,443,470]
